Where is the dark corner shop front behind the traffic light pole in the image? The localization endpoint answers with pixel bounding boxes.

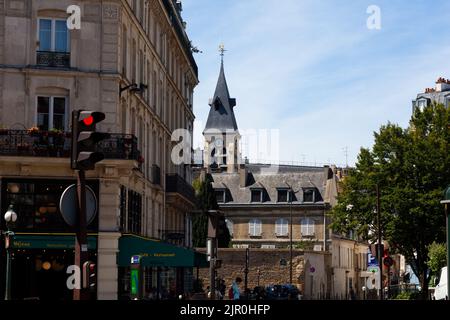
[0,178,98,300]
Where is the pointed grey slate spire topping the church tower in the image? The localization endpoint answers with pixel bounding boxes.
[205,56,238,131]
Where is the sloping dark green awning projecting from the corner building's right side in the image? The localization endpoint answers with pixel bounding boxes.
[117,234,209,268]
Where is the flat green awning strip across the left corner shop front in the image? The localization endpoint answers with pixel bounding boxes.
[11,233,97,250]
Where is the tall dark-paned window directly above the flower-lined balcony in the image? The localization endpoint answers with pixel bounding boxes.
[37,97,67,131]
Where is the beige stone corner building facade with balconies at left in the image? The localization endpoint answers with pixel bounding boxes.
[0,0,198,299]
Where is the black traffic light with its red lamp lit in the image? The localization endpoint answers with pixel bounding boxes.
[70,110,110,170]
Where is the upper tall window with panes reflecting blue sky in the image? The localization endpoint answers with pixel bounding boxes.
[39,19,70,52]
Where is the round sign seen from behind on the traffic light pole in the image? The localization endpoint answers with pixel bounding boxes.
[59,184,97,227]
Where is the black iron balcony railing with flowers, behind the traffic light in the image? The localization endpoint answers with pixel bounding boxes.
[0,129,141,161]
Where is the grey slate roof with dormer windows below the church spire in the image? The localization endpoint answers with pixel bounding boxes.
[211,164,335,205]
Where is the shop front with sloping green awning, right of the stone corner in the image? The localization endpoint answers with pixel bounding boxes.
[117,234,209,299]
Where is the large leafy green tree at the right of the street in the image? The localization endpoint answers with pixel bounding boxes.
[332,103,450,297]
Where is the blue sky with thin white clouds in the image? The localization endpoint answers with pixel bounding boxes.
[182,0,450,165]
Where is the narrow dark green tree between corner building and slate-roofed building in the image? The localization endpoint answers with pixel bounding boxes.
[192,175,230,248]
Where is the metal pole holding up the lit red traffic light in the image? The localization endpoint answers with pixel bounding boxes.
[73,170,88,300]
